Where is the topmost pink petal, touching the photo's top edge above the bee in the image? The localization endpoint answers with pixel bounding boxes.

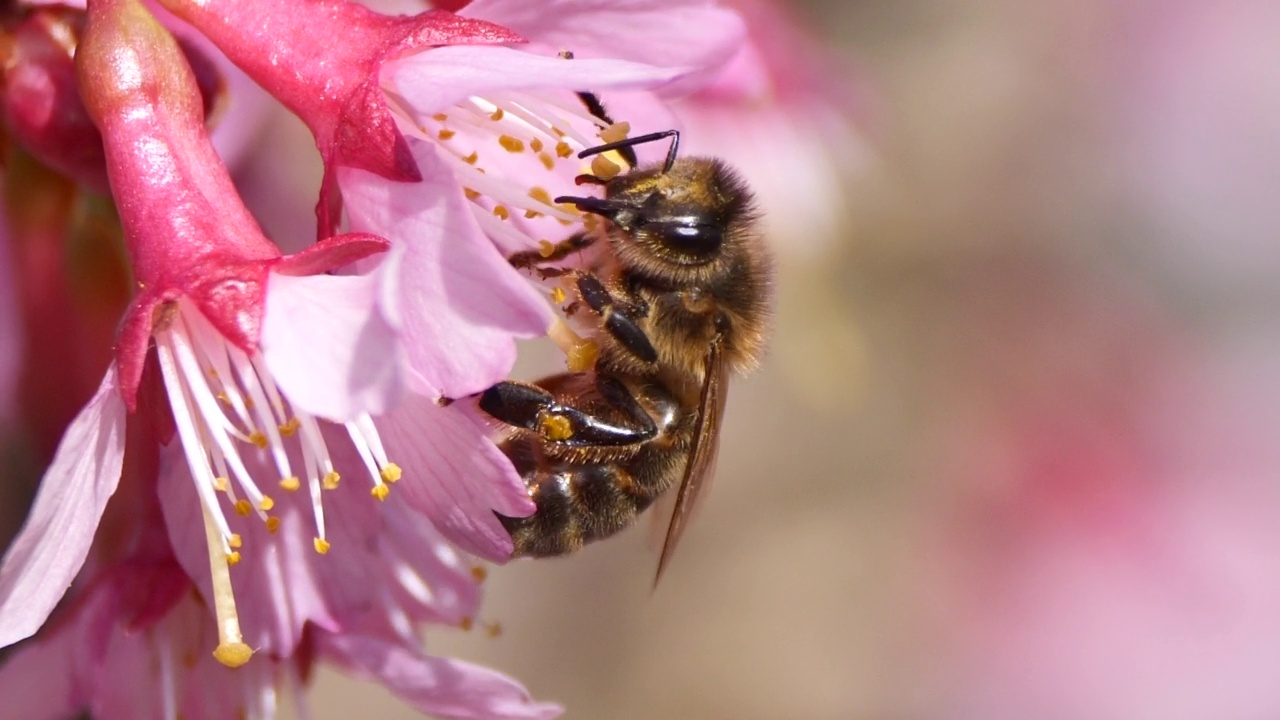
[460,0,746,92]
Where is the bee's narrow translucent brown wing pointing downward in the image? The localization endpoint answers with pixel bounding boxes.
[653,340,728,587]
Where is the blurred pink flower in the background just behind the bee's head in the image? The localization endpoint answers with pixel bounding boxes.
[673,0,870,259]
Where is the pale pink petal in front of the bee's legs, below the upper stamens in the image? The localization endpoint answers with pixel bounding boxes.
[339,137,552,397]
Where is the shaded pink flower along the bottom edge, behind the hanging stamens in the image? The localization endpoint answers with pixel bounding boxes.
[0,506,559,720]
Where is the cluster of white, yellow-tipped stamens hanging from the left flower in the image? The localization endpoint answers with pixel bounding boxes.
[155,299,401,666]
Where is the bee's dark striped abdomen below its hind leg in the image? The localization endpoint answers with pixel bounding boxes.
[500,464,655,557]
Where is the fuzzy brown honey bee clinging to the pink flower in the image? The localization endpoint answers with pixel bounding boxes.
[479,112,772,583]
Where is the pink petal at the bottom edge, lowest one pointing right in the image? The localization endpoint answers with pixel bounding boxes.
[317,633,563,720]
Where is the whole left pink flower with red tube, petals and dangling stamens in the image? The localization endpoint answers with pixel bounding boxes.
[0,0,558,717]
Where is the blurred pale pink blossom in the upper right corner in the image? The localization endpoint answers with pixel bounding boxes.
[1106,0,1280,292]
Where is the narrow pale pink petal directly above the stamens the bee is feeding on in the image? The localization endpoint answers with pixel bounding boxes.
[385,45,687,115]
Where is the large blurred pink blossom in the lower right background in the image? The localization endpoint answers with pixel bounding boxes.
[922,257,1280,720]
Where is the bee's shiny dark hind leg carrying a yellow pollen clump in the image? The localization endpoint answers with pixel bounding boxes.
[480,378,658,447]
